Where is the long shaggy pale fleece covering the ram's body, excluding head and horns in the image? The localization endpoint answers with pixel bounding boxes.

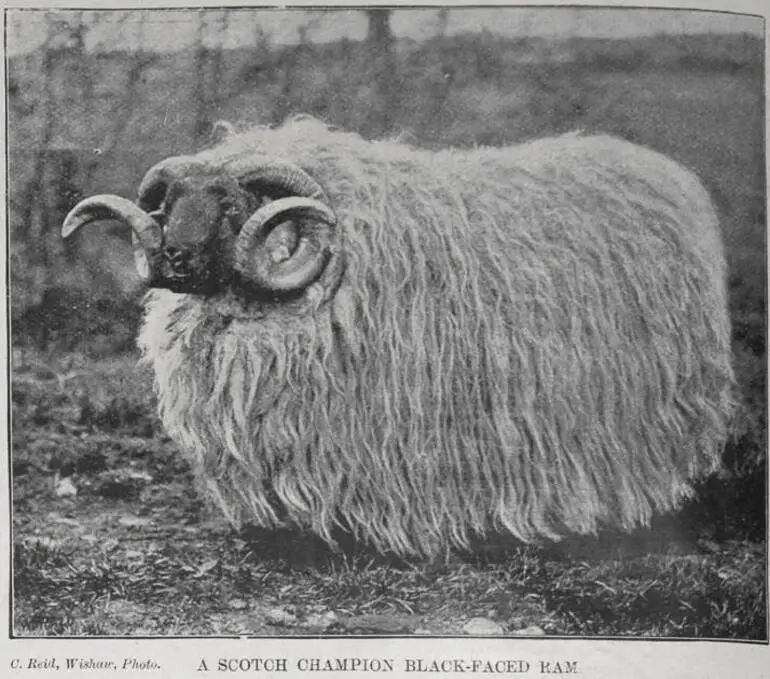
[140,119,733,556]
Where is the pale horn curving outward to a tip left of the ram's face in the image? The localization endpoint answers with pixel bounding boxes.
[62,195,163,281]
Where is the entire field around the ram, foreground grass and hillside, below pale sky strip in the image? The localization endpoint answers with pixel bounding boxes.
[8,22,767,639]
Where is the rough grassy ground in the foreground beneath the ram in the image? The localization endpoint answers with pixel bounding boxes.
[13,352,767,640]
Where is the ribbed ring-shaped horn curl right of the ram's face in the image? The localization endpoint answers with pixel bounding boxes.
[235,196,337,293]
